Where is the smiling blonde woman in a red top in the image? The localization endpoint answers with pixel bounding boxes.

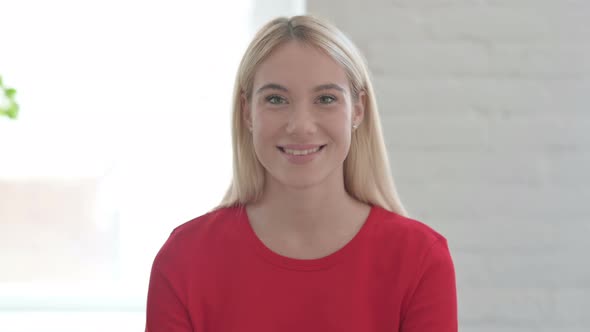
[146,16,457,332]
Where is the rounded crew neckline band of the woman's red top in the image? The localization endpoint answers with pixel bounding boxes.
[238,205,378,271]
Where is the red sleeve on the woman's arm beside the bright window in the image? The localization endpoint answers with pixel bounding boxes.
[145,253,193,332]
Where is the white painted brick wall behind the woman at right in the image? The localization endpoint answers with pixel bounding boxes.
[307,0,590,332]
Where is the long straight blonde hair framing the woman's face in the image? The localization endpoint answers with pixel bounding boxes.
[217,15,407,216]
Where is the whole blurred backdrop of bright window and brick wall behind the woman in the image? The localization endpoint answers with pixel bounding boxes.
[0,0,590,332]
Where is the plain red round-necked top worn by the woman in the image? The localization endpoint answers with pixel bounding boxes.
[146,206,457,332]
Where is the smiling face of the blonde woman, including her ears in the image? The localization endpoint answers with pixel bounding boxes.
[242,42,365,188]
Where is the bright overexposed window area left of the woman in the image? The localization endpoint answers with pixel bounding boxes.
[0,0,303,331]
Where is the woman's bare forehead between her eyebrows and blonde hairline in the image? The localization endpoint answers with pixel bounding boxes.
[254,41,348,90]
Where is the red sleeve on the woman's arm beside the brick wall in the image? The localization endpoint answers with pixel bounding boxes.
[400,239,458,332]
